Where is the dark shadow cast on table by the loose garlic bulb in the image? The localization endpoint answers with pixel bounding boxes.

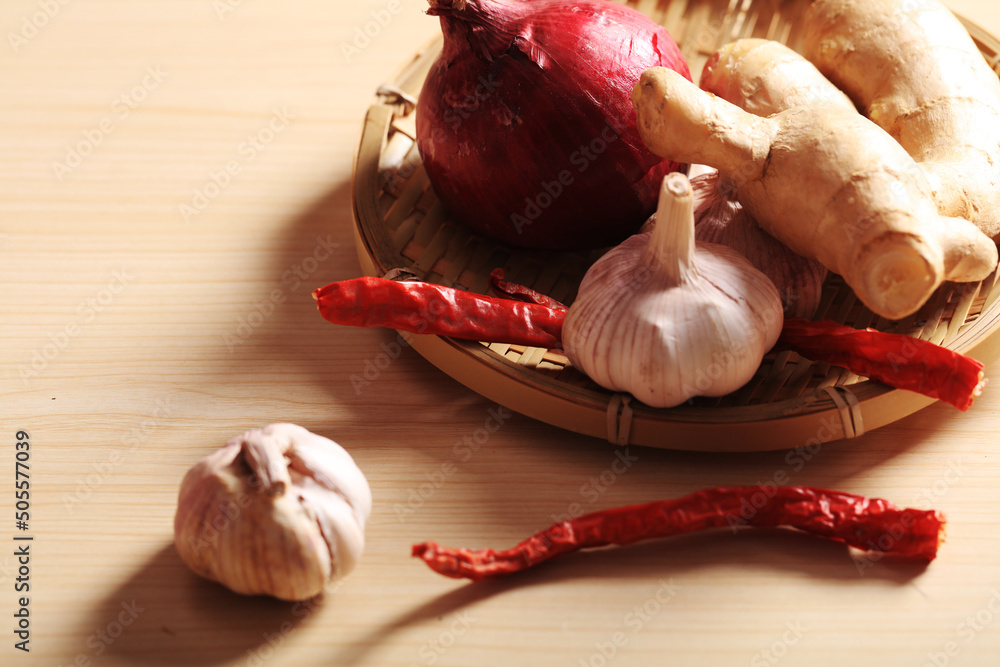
[78,544,323,667]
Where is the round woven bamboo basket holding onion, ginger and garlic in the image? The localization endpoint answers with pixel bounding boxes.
[352,0,1000,451]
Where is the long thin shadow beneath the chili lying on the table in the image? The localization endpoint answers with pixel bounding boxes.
[331,529,927,665]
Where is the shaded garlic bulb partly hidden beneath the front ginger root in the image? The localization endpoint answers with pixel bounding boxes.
[691,172,827,318]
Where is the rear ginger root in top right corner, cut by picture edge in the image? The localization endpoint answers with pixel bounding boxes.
[800,0,1000,240]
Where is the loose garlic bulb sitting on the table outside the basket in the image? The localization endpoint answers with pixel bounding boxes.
[174,424,372,600]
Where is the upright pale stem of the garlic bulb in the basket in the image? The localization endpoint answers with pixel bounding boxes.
[643,173,697,285]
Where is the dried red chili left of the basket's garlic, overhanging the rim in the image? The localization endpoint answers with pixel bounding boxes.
[313,278,565,348]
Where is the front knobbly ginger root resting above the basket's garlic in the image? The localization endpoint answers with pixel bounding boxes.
[632,67,997,319]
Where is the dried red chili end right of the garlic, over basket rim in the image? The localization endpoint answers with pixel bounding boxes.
[776,317,986,411]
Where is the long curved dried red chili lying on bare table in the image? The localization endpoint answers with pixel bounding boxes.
[412,486,944,581]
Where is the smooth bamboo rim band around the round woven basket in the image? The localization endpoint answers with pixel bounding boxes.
[351,0,1000,452]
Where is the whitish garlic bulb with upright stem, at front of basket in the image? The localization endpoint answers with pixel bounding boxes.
[563,173,783,407]
